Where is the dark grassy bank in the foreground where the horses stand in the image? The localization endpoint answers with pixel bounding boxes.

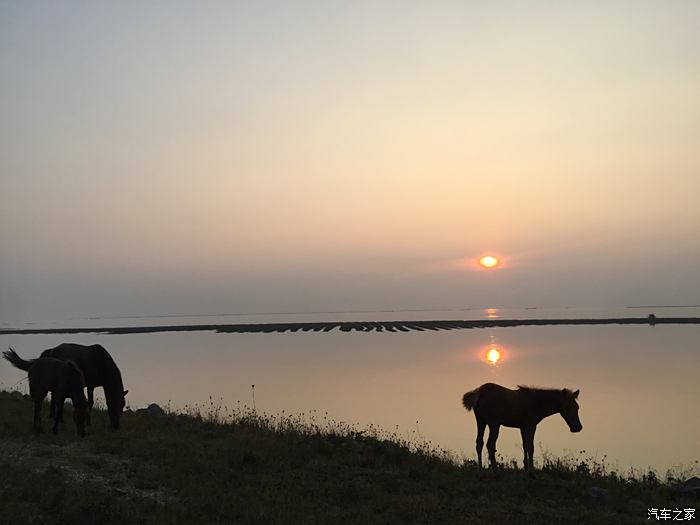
[0,386,698,525]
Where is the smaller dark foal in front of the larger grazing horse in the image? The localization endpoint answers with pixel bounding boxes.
[3,348,87,437]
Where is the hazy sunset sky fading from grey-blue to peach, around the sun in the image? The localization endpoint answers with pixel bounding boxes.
[0,1,700,322]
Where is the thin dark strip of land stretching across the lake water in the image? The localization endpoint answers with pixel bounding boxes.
[0,317,700,335]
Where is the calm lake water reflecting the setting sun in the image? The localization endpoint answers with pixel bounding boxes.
[0,302,700,474]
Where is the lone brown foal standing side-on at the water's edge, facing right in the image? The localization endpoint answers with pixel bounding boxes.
[462,383,583,471]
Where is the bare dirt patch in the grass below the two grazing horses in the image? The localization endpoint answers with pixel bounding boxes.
[0,440,176,505]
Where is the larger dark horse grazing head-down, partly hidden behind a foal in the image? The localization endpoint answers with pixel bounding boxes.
[3,343,128,429]
